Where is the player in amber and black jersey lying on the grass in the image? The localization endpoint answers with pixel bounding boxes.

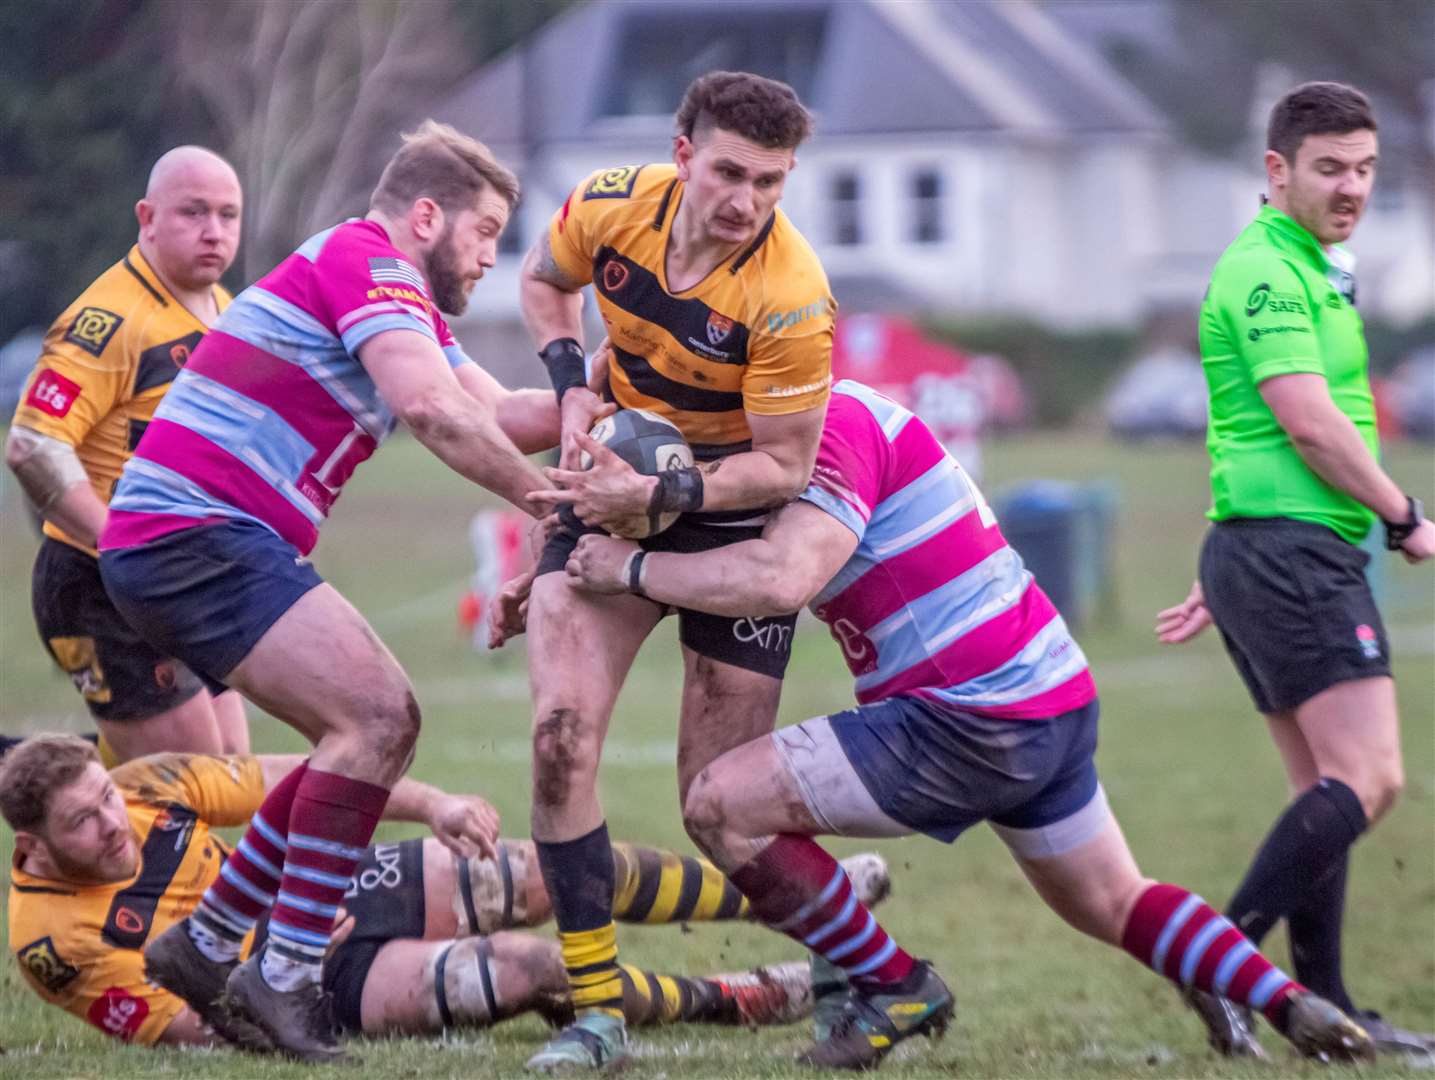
[0,736,888,1048]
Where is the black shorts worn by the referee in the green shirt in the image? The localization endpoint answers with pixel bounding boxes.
[1200,518,1391,714]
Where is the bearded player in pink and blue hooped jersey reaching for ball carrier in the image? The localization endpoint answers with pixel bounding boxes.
[91,122,558,1060]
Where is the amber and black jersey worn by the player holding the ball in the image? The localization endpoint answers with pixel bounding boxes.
[548,165,837,460]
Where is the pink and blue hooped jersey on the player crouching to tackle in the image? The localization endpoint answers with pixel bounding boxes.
[801,380,1096,720]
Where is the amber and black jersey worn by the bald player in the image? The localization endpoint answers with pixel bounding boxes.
[14,244,230,555]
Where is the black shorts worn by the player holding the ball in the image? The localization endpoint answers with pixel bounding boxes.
[538,511,798,678]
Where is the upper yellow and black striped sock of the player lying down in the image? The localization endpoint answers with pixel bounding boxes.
[613,843,748,922]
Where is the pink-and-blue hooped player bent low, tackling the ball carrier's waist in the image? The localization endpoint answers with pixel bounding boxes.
[553,382,1370,1069]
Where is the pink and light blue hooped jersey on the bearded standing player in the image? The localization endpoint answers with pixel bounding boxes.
[99,219,469,555]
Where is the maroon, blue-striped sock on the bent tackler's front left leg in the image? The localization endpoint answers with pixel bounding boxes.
[730,833,916,985]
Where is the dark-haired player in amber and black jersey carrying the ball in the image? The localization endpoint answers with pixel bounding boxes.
[521,72,834,1070]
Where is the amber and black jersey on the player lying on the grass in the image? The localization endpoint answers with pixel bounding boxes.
[9,754,264,1044]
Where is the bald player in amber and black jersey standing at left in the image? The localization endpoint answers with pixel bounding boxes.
[6,146,250,764]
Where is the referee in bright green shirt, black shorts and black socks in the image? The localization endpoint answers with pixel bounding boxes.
[1157,82,1435,1064]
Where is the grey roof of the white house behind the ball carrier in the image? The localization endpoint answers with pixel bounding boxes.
[436,0,1167,149]
